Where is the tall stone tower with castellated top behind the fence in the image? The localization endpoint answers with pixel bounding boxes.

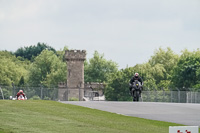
[58,50,86,101]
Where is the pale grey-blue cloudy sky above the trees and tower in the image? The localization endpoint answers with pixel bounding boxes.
[0,0,200,69]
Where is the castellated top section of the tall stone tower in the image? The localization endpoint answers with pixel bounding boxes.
[65,50,86,61]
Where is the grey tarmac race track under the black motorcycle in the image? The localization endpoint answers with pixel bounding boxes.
[60,101,200,126]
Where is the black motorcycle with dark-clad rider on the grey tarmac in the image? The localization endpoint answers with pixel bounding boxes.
[131,80,142,101]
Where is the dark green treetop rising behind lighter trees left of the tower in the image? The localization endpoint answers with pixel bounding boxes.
[14,43,56,60]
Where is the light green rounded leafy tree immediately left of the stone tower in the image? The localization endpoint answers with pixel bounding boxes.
[29,50,67,87]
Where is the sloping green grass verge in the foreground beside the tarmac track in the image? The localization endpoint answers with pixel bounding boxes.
[0,100,198,133]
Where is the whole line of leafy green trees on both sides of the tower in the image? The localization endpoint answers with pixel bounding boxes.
[0,43,200,101]
